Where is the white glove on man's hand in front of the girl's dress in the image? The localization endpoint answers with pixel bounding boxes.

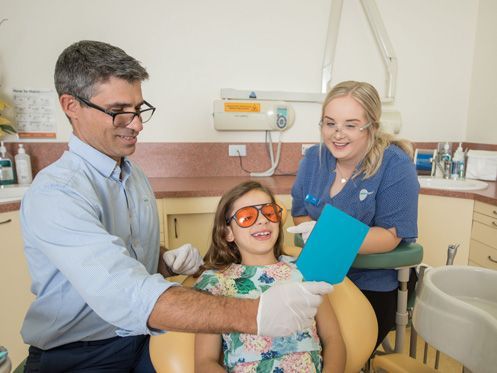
[257,282,333,337]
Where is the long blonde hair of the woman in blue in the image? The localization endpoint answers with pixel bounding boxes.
[321,81,413,179]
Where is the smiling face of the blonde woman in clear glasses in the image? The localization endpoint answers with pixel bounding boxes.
[321,96,370,164]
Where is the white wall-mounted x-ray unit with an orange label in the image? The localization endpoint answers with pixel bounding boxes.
[213,100,295,131]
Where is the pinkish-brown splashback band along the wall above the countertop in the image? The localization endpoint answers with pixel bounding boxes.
[1,142,497,177]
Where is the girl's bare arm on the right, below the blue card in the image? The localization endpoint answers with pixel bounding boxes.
[316,296,347,372]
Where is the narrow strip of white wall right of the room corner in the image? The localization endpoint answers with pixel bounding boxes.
[466,0,497,144]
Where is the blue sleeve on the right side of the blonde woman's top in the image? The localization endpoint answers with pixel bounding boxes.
[373,152,419,242]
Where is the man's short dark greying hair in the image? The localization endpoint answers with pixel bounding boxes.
[54,40,148,100]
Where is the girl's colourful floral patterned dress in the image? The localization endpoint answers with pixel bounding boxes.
[195,256,322,373]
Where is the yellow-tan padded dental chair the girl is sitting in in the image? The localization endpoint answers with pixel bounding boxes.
[150,272,378,373]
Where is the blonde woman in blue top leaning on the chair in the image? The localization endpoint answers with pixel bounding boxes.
[292,81,419,346]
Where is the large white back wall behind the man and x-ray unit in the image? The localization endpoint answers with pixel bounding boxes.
[0,0,482,142]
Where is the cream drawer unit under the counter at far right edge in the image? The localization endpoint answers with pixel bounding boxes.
[469,201,497,270]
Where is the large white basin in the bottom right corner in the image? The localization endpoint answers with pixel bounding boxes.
[413,266,497,372]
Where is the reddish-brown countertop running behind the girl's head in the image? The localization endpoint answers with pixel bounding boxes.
[0,176,497,212]
